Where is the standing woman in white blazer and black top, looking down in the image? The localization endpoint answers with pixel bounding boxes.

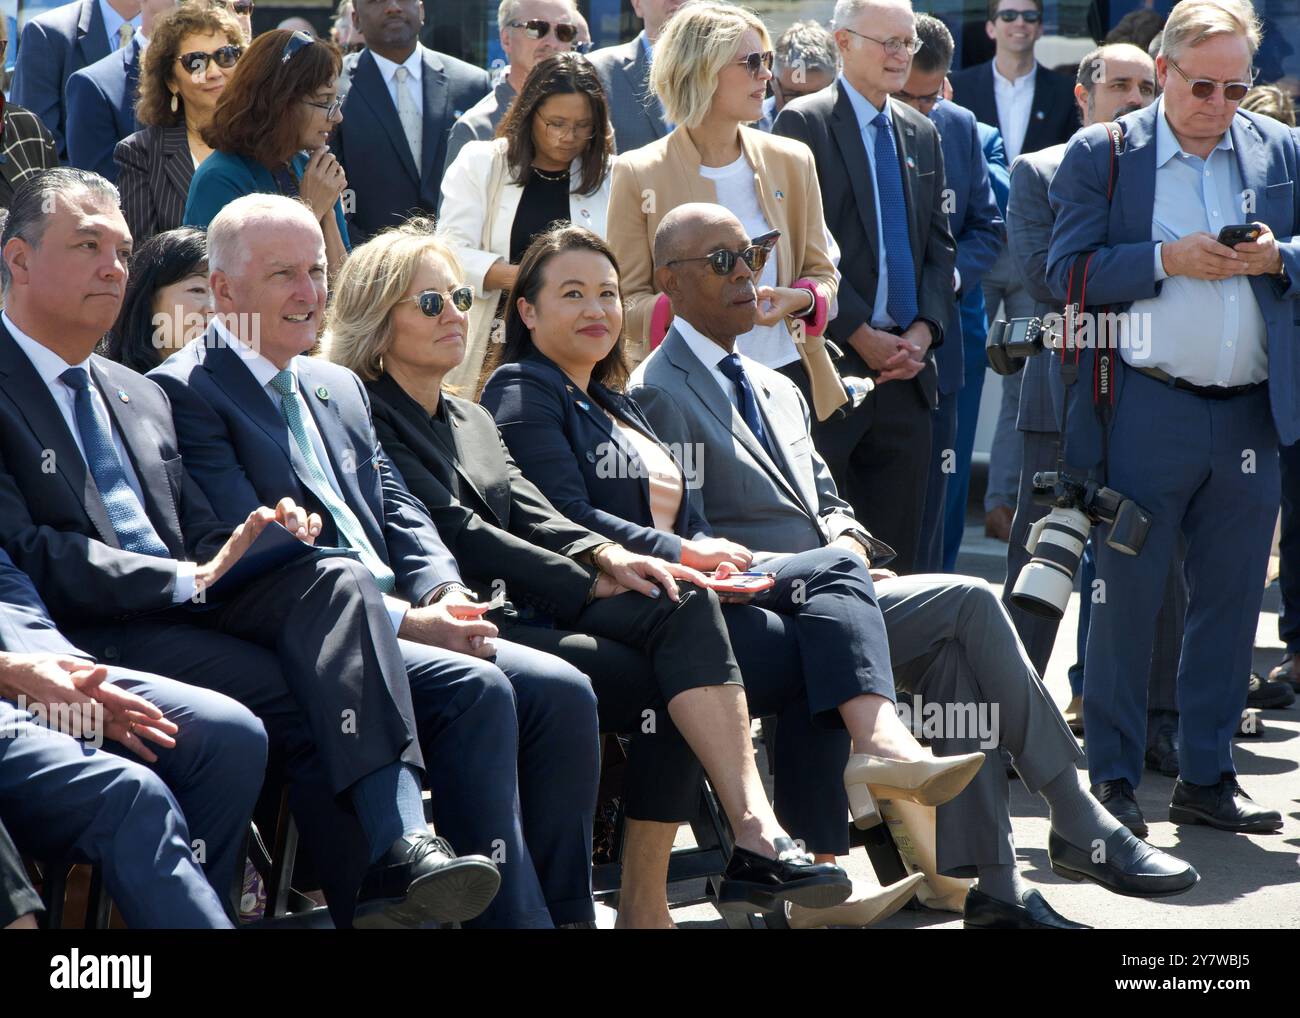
[438,53,614,398]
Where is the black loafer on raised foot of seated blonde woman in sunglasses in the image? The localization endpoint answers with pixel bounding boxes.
[718,837,853,911]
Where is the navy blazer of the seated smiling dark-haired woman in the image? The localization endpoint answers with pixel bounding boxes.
[482,351,711,562]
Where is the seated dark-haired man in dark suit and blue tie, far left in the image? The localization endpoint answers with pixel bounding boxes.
[0,168,499,924]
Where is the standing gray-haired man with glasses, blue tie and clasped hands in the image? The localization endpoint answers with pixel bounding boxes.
[772,0,957,572]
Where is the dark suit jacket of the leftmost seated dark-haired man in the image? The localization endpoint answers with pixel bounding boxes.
[0,325,233,625]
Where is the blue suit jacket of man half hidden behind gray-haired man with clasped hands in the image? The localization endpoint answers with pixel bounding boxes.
[930,103,1002,395]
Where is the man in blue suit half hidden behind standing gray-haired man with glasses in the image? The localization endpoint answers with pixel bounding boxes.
[894,14,1002,572]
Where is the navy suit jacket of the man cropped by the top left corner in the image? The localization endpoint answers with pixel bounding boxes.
[9,0,116,159]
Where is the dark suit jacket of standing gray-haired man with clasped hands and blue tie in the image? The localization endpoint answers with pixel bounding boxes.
[772,81,957,406]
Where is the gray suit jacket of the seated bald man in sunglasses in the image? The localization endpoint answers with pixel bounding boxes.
[628,329,893,564]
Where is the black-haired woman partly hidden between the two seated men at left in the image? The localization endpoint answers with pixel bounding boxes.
[103,226,212,374]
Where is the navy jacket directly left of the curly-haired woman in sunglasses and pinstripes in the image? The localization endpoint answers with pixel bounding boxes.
[68,39,143,183]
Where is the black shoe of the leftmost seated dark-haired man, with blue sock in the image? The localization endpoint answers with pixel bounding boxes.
[352,835,501,930]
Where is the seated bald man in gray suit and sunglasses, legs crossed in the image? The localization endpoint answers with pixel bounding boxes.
[631,204,1197,928]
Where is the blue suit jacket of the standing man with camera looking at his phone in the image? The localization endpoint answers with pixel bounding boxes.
[1048,103,1300,469]
